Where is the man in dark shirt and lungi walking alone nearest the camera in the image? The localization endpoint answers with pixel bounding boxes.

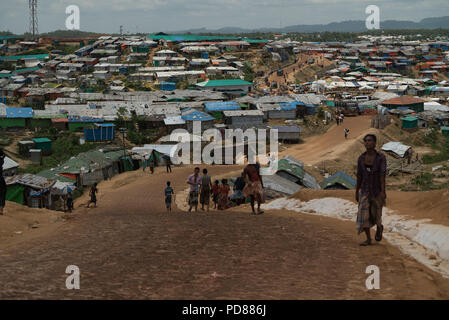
[355,134,387,246]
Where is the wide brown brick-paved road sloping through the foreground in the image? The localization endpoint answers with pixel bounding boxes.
[0,166,449,299]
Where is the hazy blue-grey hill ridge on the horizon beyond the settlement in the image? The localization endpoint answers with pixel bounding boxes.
[173,16,449,34]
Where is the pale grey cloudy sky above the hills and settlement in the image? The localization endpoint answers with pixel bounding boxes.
[0,0,449,33]
